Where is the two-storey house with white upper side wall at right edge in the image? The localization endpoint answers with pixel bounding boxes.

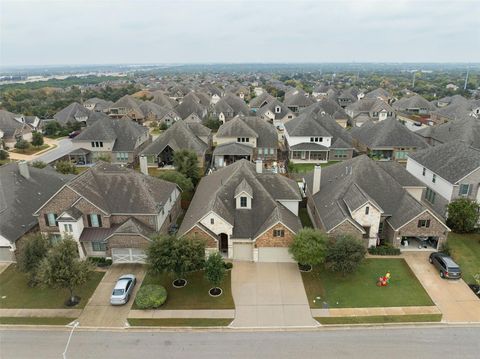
[407,140,480,217]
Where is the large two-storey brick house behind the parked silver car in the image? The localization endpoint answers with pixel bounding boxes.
[34,162,181,263]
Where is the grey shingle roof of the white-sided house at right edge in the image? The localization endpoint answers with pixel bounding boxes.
[409,141,480,183]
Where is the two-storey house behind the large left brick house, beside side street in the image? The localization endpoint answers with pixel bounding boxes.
[69,117,151,164]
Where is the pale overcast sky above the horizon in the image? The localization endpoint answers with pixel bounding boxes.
[0,0,480,66]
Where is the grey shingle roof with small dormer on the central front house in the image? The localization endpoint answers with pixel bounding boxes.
[179,160,301,239]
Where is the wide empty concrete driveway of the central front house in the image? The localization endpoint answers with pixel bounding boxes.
[230,262,318,328]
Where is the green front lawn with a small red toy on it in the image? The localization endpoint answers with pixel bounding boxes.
[302,258,434,308]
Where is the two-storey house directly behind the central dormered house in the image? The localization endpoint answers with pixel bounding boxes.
[213,116,278,168]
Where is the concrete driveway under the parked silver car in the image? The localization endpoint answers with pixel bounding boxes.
[78,264,145,327]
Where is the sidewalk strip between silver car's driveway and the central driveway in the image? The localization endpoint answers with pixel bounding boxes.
[128,309,235,319]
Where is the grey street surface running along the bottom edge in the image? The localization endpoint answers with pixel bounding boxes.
[0,326,480,359]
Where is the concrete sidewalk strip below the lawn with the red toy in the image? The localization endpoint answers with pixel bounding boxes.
[311,306,442,317]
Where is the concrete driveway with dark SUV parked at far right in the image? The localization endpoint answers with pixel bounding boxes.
[404,252,480,323]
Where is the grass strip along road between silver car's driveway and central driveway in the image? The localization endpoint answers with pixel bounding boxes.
[128,318,233,327]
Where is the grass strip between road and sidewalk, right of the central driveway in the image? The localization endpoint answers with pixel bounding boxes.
[315,314,442,325]
